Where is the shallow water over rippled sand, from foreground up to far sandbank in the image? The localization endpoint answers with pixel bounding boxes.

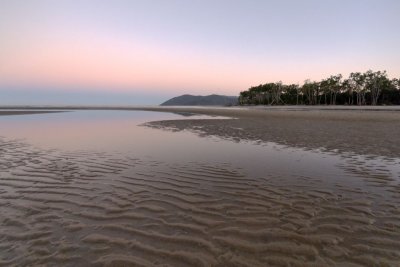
[0,111,400,266]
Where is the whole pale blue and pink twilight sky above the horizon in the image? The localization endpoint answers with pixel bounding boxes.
[0,0,400,105]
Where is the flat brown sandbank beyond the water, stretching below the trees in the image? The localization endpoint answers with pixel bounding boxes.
[0,106,400,158]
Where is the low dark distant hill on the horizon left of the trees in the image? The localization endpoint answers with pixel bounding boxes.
[161,95,238,106]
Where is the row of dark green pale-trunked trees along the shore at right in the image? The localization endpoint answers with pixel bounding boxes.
[239,70,400,106]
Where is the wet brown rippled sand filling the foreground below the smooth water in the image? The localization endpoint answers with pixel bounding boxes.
[0,139,400,266]
